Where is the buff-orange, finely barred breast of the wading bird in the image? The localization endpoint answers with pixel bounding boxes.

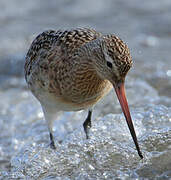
[48,62,112,109]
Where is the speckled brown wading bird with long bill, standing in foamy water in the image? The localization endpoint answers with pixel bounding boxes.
[25,28,143,158]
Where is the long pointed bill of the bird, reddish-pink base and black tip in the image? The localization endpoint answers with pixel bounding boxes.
[114,83,143,159]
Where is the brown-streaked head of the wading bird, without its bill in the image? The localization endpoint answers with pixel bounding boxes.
[94,35,132,86]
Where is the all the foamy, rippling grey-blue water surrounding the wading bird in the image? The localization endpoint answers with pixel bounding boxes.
[0,0,171,180]
